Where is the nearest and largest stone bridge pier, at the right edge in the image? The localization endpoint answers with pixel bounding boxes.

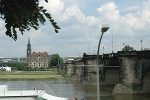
[113,51,150,94]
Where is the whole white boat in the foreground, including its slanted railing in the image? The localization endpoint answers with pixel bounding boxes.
[0,83,69,100]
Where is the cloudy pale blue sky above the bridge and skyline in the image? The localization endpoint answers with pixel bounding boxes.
[0,0,150,57]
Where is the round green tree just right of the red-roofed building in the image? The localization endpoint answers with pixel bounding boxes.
[49,54,63,68]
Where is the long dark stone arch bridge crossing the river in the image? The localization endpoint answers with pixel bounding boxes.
[59,50,150,94]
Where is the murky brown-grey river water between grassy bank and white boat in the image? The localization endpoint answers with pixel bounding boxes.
[0,79,150,100]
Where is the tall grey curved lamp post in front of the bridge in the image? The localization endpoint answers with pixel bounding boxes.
[96,24,109,100]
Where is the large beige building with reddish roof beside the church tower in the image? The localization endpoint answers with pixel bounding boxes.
[27,52,51,68]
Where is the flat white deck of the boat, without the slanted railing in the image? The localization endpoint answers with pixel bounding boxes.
[0,85,68,100]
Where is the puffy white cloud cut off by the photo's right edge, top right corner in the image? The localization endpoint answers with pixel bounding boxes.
[126,0,150,32]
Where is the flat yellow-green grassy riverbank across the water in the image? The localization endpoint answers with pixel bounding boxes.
[0,71,64,80]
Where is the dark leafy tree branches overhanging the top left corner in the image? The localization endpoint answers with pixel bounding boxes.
[0,0,60,40]
